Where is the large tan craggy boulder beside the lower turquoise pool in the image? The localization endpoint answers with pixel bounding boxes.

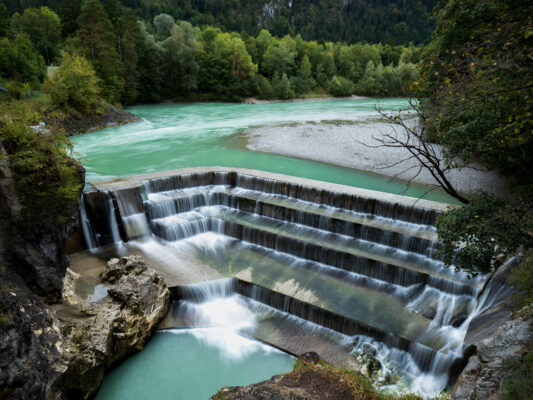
[56,256,170,399]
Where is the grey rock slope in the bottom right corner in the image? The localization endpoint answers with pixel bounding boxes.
[450,312,533,400]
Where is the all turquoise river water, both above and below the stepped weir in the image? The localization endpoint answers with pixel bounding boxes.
[73,99,466,400]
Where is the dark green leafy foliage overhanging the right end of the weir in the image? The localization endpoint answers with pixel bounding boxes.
[437,190,533,276]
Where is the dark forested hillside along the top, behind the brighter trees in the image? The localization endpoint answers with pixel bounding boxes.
[5,0,436,44]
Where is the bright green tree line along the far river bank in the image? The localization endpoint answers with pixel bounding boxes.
[0,0,421,108]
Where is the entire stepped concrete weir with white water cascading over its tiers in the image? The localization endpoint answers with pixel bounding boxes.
[76,167,502,395]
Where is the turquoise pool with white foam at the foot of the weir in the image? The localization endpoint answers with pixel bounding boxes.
[95,328,294,400]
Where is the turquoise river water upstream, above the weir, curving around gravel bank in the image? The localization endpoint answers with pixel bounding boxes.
[73,99,453,202]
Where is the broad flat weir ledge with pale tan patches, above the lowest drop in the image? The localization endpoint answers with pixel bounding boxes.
[169,242,459,349]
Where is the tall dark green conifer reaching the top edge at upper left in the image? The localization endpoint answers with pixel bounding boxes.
[77,0,124,102]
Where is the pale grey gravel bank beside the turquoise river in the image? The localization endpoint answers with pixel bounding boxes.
[242,122,505,194]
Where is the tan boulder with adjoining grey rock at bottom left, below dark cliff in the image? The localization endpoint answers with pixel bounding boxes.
[0,256,170,400]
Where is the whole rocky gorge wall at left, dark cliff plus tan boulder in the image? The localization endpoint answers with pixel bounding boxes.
[0,142,170,400]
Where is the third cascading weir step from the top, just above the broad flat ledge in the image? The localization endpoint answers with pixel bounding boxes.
[151,207,478,294]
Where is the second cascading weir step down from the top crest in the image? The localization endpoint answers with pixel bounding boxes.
[145,185,439,254]
